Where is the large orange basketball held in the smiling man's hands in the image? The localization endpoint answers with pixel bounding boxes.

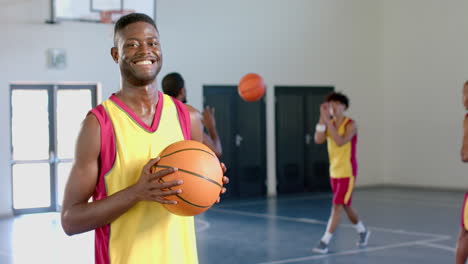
[153,140,223,216]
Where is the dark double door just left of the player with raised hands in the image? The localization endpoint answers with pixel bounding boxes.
[275,86,333,193]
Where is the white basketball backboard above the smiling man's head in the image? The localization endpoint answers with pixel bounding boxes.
[52,0,156,23]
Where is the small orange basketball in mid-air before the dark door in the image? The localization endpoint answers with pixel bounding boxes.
[237,73,265,102]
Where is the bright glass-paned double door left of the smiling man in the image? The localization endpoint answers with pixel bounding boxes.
[10,84,99,214]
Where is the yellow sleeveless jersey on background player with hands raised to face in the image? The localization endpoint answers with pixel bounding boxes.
[327,117,357,179]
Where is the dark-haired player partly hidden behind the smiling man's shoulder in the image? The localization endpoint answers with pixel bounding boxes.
[162,72,223,158]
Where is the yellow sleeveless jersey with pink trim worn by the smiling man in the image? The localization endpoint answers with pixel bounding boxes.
[91,92,198,264]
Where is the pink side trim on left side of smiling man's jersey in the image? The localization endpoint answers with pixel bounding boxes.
[90,105,116,264]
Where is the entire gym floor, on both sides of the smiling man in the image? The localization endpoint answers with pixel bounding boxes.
[0,188,464,264]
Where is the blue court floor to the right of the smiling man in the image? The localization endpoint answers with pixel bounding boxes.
[197,188,464,264]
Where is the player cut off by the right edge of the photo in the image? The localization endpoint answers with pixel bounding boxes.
[455,81,468,264]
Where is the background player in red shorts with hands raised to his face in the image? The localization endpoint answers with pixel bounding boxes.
[313,92,370,254]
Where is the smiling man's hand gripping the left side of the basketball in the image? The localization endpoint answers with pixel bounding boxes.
[132,157,183,204]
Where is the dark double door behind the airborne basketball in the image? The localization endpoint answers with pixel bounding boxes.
[203,85,266,198]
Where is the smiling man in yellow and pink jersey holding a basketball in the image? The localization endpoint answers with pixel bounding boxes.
[62,13,229,264]
